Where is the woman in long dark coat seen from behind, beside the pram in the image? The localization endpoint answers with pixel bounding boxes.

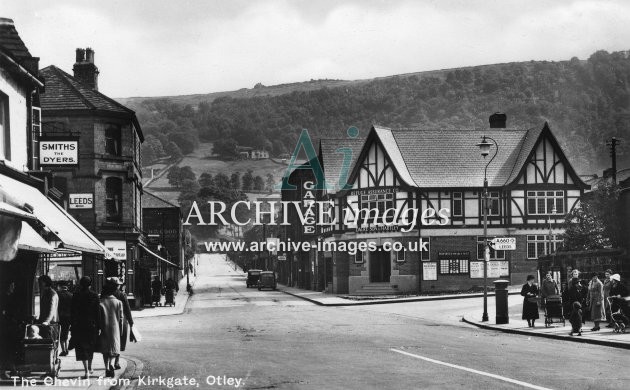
[70,276,99,379]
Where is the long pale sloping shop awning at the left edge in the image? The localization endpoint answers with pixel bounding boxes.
[0,175,106,255]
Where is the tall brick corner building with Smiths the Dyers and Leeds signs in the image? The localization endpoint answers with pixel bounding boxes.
[39,48,145,299]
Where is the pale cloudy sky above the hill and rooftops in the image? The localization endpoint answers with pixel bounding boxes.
[0,0,630,97]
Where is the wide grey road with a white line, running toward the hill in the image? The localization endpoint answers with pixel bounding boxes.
[126,255,630,389]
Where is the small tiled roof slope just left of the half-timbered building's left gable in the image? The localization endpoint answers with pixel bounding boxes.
[319,138,365,193]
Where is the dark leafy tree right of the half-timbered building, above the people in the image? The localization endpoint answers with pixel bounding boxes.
[563,182,622,250]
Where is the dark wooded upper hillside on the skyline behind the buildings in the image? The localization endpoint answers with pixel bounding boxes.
[120,51,630,174]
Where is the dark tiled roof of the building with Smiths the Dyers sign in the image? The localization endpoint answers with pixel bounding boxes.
[40,65,135,116]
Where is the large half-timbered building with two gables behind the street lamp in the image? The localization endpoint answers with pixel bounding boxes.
[283,114,588,295]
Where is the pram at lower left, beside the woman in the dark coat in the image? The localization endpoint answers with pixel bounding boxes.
[16,324,61,378]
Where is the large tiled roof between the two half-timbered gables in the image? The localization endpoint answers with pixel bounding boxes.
[374,126,542,188]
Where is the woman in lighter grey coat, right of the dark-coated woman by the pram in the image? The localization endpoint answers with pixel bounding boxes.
[99,282,123,378]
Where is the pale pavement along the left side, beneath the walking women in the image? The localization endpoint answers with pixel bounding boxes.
[0,274,196,390]
